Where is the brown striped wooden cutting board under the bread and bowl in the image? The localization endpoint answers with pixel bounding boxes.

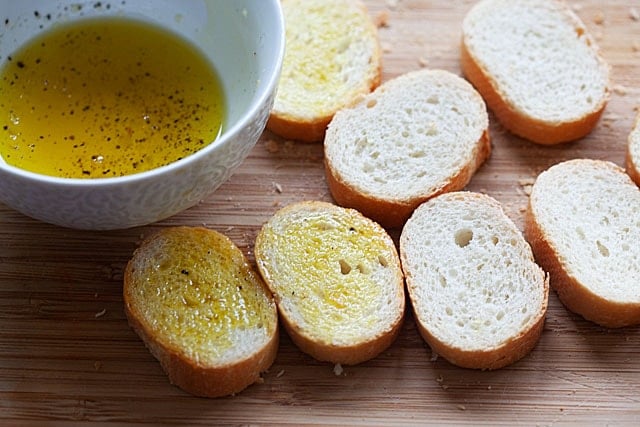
[0,0,640,426]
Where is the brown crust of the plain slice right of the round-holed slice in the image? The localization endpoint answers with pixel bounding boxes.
[524,200,640,328]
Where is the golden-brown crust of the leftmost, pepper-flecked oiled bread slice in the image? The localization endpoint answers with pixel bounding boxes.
[123,227,279,397]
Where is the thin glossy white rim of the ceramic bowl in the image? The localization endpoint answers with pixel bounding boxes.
[0,0,285,189]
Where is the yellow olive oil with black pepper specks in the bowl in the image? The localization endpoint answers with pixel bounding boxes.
[0,17,225,178]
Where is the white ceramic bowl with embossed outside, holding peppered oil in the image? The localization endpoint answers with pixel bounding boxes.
[0,0,284,230]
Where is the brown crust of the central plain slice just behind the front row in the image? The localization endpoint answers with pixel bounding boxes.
[324,129,491,228]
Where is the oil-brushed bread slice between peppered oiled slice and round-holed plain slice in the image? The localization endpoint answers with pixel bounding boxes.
[255,201,405,365]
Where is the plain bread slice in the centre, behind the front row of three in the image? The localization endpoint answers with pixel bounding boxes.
[324,70,491,231]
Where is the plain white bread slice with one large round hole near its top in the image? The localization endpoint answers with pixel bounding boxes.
[400,192,549,369]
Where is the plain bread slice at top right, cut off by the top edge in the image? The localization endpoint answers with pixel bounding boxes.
[461,0,609,144]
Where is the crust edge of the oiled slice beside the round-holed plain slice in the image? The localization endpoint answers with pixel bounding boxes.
[254,201,405,365]
